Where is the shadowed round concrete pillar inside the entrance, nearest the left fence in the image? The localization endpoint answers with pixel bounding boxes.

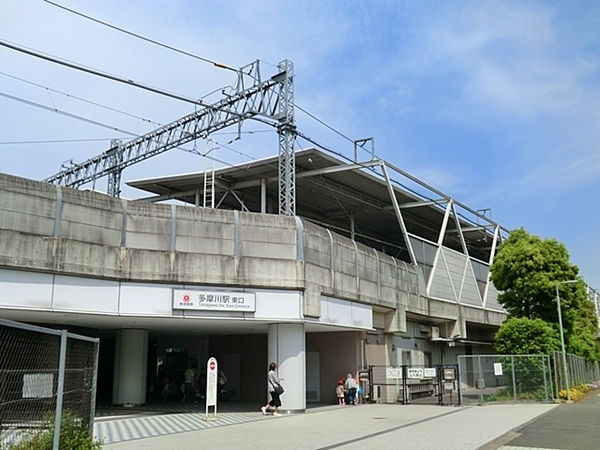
[112,329,148,405]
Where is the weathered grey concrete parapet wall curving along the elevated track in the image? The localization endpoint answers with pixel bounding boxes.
[0,174,505,326]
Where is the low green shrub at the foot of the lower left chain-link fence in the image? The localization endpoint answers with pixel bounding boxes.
[8,410,102,450]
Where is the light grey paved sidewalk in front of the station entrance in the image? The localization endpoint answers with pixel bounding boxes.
[104,404,556,450]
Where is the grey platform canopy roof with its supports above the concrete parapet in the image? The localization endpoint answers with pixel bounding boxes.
[127,148,508,262]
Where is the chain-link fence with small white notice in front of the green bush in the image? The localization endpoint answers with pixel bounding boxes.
[458,355,554,405]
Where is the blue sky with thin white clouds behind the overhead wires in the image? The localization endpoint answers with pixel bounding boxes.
[0,0,600,288]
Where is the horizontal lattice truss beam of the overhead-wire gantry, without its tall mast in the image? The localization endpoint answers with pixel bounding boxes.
[44,61,293,192]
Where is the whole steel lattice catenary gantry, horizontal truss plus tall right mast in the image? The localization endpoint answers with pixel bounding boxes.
[44,60,296,215]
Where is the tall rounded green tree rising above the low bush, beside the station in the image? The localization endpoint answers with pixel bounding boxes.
[490,228,600,359]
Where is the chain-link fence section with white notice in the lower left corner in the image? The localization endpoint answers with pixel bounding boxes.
[0,319,99,449]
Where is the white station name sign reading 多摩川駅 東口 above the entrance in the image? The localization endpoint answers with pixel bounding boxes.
[173,289,256,312]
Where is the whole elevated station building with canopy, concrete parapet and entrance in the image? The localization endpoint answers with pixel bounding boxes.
[0,148,507,411]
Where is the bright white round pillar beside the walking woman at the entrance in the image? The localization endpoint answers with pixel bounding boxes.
[268,324,306,413]
